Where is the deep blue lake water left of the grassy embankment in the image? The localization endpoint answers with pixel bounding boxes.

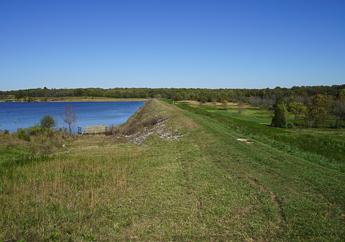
[0,102,144,132]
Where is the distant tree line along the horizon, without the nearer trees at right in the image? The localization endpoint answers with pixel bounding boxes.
[0,84,345,101]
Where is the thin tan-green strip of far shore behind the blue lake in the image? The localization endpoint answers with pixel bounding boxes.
[0,97,148,102]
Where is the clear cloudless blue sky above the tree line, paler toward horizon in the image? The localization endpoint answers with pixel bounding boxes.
[0,0,345,90]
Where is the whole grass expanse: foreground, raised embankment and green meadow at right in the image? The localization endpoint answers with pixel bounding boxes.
[0,100,345,241]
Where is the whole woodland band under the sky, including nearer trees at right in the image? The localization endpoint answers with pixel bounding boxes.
[0,84,345,127]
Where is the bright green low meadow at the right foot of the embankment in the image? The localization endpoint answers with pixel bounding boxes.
[187,104,345,164]
